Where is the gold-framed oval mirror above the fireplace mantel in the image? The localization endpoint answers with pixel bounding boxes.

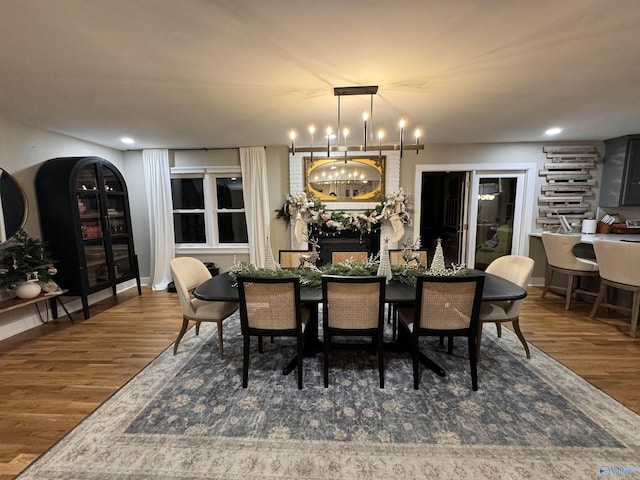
[304,155,386,203]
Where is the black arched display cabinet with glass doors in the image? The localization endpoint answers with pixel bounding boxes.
[36,157,141,318]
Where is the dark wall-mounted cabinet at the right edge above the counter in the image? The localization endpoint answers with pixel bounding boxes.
[600,135,640,207]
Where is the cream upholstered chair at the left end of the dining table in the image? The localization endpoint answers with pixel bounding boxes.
[169,257,238,357]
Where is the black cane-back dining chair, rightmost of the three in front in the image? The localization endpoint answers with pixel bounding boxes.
[398,275,484,391]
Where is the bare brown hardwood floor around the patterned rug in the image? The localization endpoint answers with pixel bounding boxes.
[0,288,640,480]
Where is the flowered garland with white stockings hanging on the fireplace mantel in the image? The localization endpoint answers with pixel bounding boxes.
[276,188,410,242]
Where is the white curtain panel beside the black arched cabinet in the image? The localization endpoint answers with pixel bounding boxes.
[142,148,175,290]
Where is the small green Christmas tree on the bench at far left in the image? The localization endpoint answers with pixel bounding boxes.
[0,230,57,289]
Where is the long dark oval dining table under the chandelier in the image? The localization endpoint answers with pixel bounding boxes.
[193,270,527,377]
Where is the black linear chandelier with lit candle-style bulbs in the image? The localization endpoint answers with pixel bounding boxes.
[289,85,424,160]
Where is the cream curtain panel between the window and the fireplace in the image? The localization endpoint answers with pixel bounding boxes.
[240,147,270,267]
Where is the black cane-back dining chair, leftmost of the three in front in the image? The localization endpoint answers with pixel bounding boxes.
[237,276,310,389]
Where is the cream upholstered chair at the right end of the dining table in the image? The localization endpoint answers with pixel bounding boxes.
[476,255,535,360]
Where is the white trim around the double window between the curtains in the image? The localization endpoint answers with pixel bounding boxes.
[171,166,249,254]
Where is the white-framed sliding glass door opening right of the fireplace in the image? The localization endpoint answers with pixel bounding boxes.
[415,164,536,270]
